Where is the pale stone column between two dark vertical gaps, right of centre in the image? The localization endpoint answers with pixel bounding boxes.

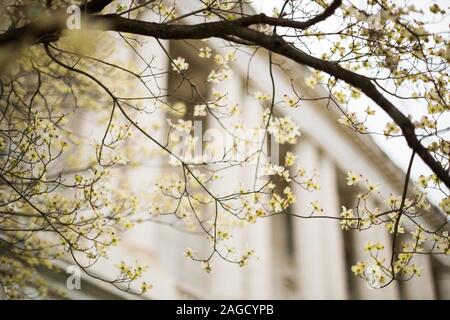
[293,138,347,299]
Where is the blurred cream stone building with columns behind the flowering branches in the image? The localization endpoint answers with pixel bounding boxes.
[46,3,450,299]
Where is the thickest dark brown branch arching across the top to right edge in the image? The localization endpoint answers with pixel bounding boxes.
[0,1,450,188]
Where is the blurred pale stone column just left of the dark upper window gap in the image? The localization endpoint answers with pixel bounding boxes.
[117,27,178,299]
